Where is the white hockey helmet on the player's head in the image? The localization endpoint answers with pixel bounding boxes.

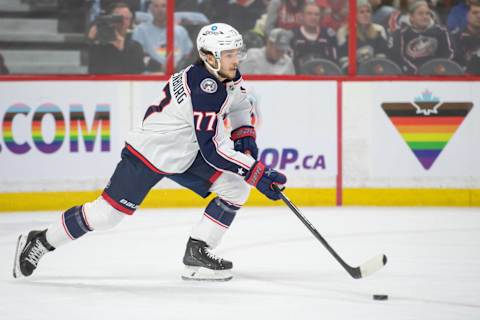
[197,23,244,60]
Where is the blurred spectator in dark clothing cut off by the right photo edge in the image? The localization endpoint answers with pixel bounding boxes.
[454,2,480,74]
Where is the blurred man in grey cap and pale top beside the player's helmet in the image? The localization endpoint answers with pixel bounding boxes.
[240,28,295,74]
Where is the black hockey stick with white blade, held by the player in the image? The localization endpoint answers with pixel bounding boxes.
[273,184,387,279]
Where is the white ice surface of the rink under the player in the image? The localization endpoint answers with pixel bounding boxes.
[0,207,480,320]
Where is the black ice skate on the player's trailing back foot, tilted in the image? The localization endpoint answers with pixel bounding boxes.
[13,230,55,278]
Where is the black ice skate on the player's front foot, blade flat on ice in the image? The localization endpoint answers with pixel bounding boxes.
[182,238,233,281]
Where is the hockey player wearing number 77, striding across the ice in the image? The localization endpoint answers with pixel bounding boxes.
[13,23,287,280]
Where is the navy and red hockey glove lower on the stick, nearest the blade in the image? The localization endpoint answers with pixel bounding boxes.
[245,161,287,200]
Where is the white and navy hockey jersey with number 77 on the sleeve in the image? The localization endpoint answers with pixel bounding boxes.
[126,64,255,176]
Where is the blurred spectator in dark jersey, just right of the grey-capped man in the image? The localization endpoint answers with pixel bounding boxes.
[292,2,338,72]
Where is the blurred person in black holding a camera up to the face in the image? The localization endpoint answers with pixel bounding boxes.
[88,2,145,74]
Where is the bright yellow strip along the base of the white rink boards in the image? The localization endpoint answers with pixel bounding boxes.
[0,188,480,212]
